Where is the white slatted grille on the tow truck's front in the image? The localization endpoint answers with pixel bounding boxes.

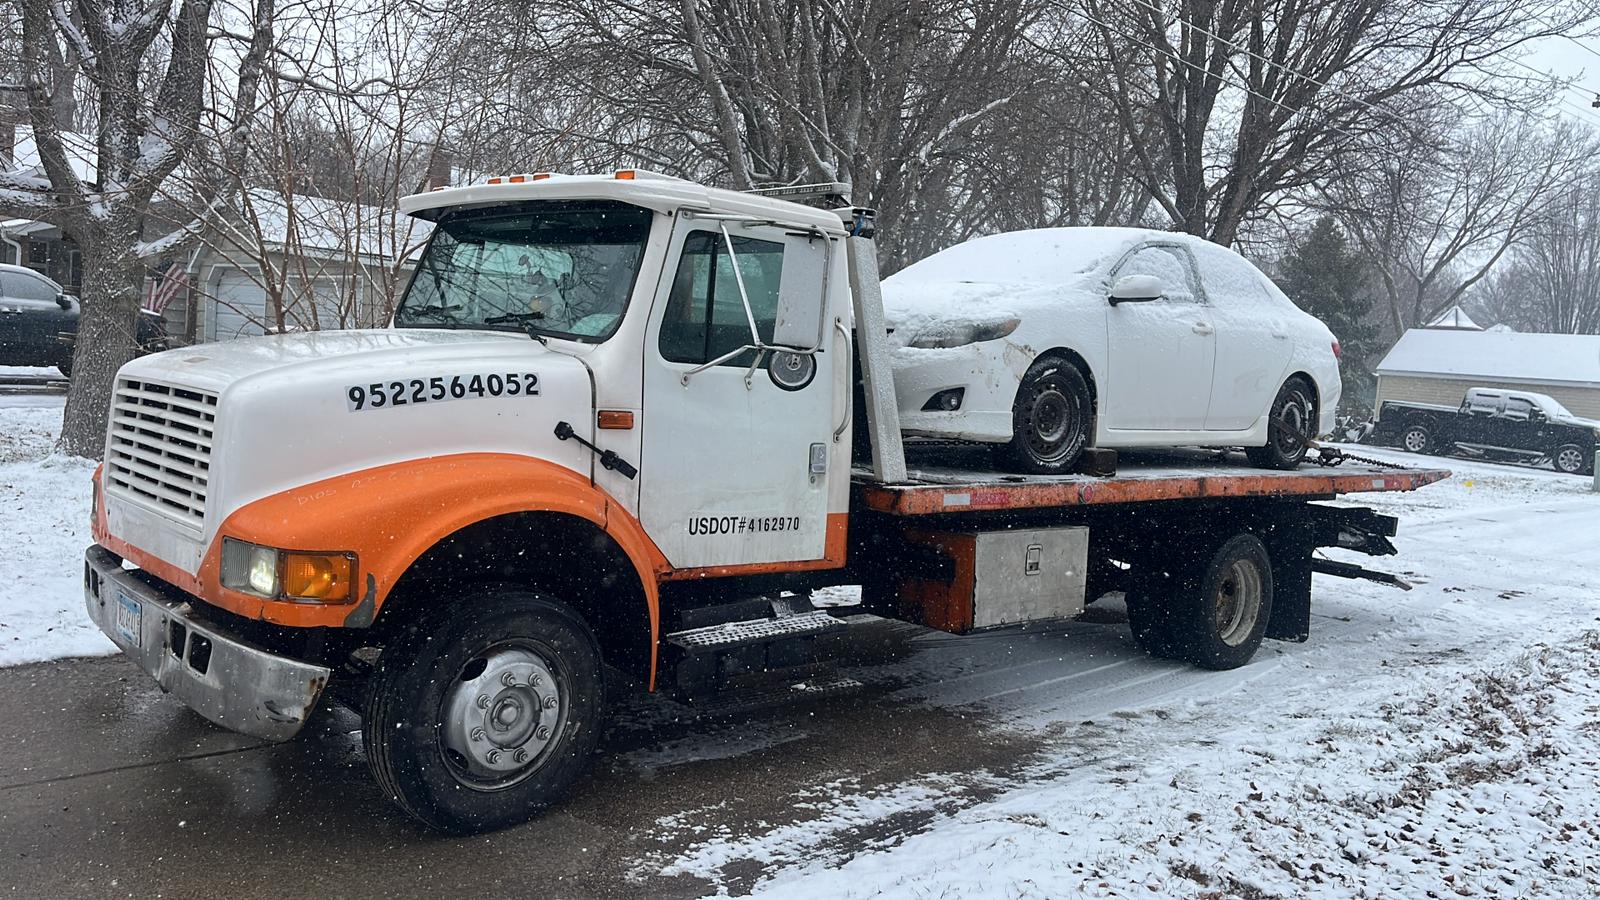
[106,378,216,527]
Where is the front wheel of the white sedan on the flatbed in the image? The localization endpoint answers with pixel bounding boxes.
[1003,356,1094,476]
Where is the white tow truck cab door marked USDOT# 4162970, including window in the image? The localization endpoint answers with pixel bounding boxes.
[638,218,848,569]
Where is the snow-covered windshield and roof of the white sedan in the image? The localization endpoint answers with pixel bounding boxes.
[886,227,1152,285]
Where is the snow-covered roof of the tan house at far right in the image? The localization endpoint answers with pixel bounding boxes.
[1378,328,1600,384]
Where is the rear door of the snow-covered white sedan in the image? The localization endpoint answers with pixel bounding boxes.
[1194,243,1294,431]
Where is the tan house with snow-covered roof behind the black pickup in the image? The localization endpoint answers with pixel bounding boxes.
[1378,328,1600,418]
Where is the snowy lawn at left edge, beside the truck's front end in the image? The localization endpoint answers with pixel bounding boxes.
[0,395,115,666]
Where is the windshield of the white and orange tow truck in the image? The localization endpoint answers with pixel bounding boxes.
[395,200,651,343]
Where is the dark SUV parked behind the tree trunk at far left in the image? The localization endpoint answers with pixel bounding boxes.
[0,263,170,376]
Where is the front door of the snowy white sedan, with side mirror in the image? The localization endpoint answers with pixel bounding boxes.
[1099,243,1216,431]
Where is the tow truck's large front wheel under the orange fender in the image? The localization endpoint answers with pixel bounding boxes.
[362,591,605,834]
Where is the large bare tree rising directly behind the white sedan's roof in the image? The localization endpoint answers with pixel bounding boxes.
[1082,0,1586,245]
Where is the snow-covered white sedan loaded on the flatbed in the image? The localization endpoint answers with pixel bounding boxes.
[883,227,1339,474]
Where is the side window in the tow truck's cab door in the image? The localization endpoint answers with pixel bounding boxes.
[661,231,784,365]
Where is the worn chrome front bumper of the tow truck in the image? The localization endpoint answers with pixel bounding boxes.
[83,544,330,741]
